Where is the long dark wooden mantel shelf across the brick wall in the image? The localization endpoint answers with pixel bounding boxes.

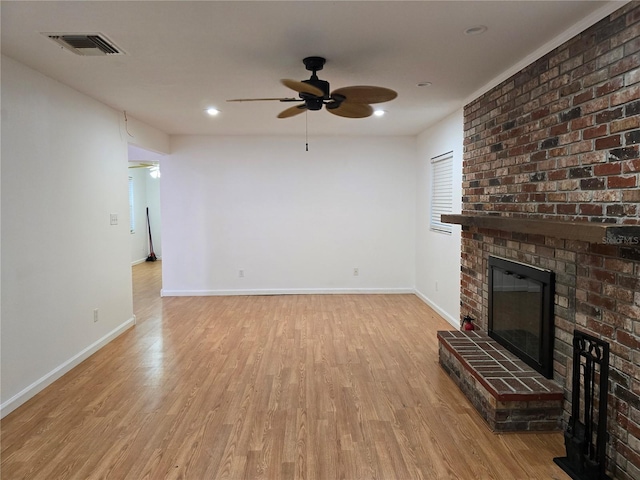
[441,213,640,247]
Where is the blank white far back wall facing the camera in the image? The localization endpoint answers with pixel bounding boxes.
[161,136,416,295]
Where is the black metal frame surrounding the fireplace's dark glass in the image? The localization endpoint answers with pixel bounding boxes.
[488,256,555,378]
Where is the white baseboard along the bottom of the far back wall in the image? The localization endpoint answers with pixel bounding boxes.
[160,288,415,297]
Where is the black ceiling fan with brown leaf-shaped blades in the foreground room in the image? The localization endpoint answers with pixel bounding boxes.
[227,57,398,118]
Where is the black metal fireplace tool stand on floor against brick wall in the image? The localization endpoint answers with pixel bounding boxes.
[553,330,609,480]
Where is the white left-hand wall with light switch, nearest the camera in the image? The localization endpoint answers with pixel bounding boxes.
[1,56,168,415]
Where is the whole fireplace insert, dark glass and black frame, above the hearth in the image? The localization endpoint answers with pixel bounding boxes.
[488,256,555,378]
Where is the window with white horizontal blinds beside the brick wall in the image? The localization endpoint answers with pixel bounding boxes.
[429,151,453,235]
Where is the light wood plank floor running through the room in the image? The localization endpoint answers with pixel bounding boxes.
[2,262,569,480]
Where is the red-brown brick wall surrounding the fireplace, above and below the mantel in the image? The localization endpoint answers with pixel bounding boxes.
[461,2,640,480]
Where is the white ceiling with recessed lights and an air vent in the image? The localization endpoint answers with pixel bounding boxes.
[1,0,626,135]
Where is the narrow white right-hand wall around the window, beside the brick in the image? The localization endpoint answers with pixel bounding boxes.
[416,109,463,326]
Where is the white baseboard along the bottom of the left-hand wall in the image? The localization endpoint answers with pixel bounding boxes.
[0,315,136,418]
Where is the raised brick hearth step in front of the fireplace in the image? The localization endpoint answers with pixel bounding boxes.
[438,331,564,432]
